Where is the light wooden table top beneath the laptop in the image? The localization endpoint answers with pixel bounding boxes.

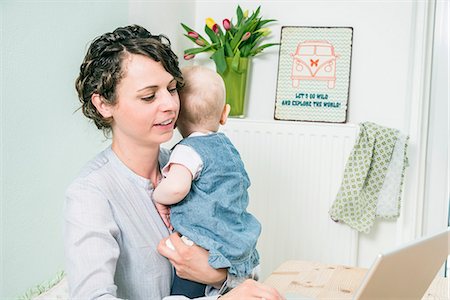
[265,260,449,300]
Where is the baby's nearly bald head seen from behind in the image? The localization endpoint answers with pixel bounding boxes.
[177,66,230,137]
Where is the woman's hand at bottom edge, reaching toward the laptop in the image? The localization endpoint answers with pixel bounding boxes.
[220,279,284,300]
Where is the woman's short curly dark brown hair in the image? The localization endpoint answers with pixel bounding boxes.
[75,25,184,135]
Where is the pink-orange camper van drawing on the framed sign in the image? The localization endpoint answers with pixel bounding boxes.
[291,41,338,89]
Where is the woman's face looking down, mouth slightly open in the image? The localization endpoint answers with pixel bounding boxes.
[111,54,180,147]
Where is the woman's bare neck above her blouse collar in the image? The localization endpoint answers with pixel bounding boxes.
[111,139,160,186]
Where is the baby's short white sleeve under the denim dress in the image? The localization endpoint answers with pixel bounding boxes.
[161,145,203,179]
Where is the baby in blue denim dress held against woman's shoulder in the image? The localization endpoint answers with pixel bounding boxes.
[153,66,261,296]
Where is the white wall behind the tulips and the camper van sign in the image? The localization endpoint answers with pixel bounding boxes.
[190,1,413,129]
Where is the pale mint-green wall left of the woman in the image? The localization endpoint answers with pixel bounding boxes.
[0,1,128,299]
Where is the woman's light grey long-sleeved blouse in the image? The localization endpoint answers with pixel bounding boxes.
[64,147,172,300]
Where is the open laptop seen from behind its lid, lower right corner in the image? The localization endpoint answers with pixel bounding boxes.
[353,229,450,300]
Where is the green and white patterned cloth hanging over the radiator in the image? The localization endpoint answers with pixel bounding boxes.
[329,122,408,233]
